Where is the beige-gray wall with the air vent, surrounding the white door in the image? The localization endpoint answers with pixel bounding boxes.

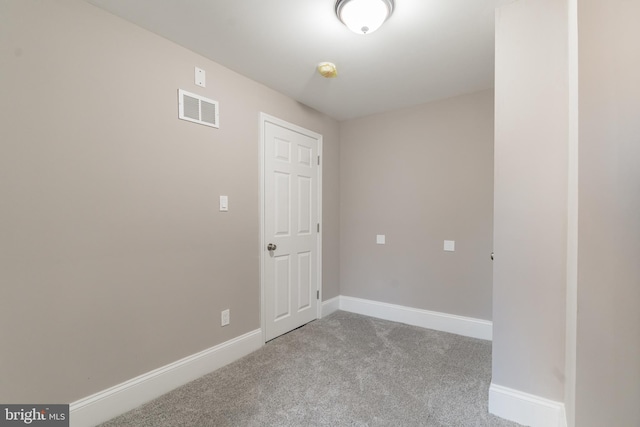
[0,0,339,403]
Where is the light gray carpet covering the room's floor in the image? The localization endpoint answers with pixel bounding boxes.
[103,311,517,427]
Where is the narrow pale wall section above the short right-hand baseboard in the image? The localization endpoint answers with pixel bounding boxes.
[492,0,569,401]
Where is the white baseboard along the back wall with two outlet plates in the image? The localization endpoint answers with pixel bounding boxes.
[339,296,493,341]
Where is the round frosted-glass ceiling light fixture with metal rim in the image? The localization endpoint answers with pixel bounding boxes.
[336,0,394,34]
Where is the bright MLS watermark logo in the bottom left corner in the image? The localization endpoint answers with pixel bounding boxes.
[0,405,69,427]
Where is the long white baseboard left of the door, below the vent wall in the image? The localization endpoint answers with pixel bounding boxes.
[69,329,264,427]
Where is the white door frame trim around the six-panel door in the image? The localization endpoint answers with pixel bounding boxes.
[258,112,324,342]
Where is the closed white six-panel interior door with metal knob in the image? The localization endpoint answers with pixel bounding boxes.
[262,116,321,341]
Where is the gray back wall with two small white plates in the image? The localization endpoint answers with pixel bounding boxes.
[340,91,493,319]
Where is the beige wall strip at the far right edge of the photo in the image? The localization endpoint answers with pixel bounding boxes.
[576,0,640,427]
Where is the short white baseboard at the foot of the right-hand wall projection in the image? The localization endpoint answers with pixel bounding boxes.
[489,383,567,427]
